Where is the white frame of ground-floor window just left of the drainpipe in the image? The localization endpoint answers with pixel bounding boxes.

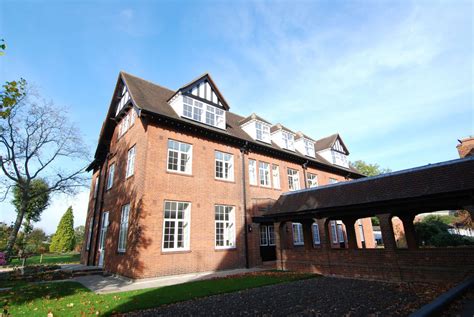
[214,205,236,249]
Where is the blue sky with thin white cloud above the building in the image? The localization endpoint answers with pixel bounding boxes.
[0,0,474,232]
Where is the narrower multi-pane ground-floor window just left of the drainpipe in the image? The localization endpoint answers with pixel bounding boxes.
[215,205,235,248]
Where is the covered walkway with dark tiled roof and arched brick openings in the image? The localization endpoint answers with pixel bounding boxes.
[254,157,474,282]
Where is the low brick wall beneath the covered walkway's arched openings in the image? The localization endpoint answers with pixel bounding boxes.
[277,248,474,283]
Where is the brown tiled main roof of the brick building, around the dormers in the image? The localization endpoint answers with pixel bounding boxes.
[89,72,363,178]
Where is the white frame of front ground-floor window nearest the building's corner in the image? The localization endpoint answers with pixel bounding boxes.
[161,200,191,252]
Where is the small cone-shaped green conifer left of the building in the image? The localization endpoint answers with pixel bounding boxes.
[49,207,76,252]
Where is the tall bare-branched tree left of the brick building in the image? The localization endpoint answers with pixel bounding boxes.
[0,83,88,257]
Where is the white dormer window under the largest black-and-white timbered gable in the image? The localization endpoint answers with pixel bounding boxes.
[180,96,225,129]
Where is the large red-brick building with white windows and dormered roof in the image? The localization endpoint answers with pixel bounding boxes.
[81,72,374,278]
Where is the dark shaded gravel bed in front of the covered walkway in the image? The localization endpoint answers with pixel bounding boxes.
[125,277,444,316]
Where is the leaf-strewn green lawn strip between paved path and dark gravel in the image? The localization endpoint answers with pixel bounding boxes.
[0,272,317,317]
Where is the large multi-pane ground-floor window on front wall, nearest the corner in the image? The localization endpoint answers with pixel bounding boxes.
[163,201,191,251]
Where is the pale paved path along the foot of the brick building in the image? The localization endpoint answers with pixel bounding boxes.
[73,268,263,294]
